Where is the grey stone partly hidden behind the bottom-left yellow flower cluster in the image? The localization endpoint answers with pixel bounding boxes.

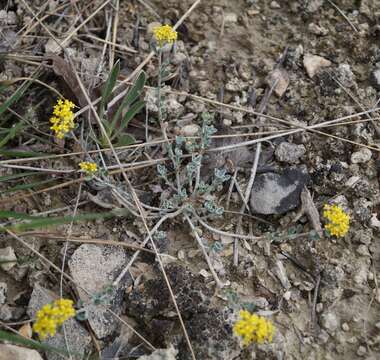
[27,284,91,360]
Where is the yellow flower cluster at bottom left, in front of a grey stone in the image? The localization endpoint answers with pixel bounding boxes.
[33,299,75,339]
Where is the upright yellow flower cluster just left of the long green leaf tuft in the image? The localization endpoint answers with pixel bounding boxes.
[50,99,75,139]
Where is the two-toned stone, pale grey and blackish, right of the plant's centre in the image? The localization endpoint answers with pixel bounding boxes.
[250,169,309,215]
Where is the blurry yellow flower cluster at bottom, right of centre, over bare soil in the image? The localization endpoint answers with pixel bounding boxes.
[234,310,274,345]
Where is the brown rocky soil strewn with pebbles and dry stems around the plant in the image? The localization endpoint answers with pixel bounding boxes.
[0,0,380,360]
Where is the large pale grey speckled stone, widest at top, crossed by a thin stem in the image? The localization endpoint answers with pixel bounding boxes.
[69,244,131,339]
